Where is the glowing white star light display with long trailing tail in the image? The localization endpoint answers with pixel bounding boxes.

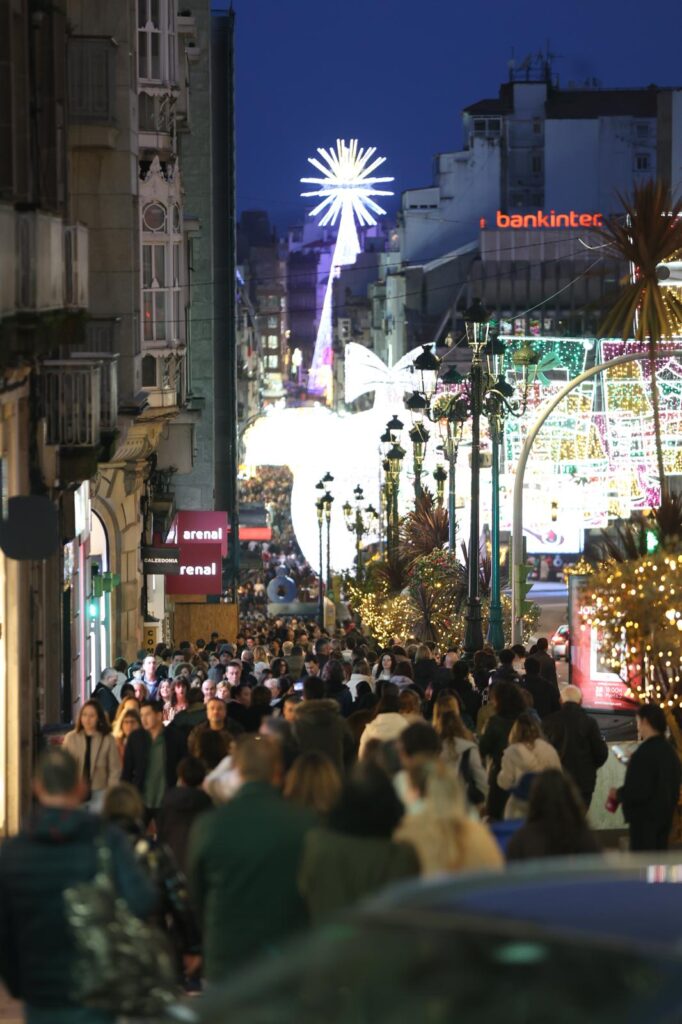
[301,138,393,395]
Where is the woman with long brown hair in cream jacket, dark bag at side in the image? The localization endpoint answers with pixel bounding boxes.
[498,712,561,819]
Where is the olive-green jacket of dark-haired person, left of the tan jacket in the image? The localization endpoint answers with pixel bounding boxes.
[299,828,419,924]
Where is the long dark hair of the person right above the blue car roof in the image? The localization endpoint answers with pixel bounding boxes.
[526,768,596,855]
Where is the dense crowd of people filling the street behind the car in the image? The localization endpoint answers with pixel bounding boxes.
[0,618,680,1022]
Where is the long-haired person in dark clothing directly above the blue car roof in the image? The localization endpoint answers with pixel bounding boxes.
[507,768,599,860]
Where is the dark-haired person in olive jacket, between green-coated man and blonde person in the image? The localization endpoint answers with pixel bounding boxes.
[299,764,420,924]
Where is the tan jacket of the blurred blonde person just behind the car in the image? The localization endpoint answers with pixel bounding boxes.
[393,802,505,876]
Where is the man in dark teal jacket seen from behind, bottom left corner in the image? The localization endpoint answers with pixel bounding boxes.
[0,749,157,1024]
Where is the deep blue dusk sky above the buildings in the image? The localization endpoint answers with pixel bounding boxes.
[233,0,682,231]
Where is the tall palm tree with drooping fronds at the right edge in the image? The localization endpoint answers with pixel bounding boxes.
[598,180,682,498]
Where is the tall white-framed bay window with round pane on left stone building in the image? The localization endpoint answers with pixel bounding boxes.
[141,201,184,347]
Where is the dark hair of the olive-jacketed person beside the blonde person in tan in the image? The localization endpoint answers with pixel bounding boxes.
[329,762,403,839]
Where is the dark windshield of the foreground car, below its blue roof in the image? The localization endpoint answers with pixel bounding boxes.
[195,910,680,1024]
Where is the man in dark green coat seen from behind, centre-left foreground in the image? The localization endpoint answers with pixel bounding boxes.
[187,736,314,982]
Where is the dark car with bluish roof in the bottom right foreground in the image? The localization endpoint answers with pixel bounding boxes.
[169,854,682,1024]
